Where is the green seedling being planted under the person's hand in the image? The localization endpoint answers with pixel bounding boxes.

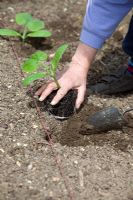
[22,44,68,88]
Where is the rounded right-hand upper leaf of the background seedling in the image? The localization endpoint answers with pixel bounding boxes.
[27,19,44,32]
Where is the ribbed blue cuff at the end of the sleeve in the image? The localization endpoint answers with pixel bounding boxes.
[80,29,105,49]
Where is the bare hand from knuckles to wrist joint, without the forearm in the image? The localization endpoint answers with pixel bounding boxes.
[35,61,88,109]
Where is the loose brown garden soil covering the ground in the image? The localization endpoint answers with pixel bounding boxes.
[0,0,133,200]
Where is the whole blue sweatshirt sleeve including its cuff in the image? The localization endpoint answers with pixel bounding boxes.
[80,0,133,49]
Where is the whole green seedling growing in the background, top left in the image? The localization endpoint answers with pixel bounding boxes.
[0,13,51,41]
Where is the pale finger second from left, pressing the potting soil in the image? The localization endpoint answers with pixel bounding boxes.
[39,83,57,101]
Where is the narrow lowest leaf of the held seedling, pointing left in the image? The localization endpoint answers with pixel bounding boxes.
[22,73,46,86]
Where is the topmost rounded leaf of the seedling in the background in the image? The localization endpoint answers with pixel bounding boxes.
[16,13,32,25]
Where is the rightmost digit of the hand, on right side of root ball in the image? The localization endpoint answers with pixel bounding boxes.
[75,86,86,109]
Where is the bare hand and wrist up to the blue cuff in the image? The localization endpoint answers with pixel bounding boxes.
[35,43,97,109]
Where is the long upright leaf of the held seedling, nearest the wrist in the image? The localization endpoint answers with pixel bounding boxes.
[51,44,68,72]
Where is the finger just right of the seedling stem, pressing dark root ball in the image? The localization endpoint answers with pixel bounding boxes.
[51,88,69,105]
